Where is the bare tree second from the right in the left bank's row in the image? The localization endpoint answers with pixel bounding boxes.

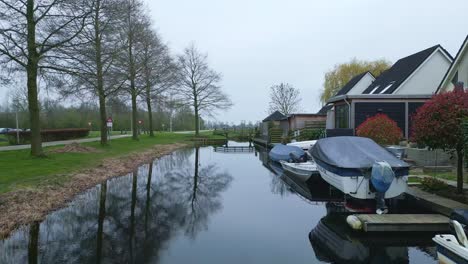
[142,24,177,137]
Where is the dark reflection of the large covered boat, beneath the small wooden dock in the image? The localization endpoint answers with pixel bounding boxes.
[309,213,435,264]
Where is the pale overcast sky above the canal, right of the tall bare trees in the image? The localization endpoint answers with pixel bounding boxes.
[145,0,468,123]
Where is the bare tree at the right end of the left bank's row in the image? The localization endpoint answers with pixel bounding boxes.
[177,44,232,136]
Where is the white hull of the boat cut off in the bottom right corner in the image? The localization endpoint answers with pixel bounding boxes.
[432,235,468,264]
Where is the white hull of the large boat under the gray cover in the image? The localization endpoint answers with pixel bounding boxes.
[317,164,408,199]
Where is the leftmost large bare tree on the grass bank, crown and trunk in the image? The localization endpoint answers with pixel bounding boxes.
[0,0,88,156]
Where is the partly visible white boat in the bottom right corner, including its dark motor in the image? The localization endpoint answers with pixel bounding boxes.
[432,220,468,264]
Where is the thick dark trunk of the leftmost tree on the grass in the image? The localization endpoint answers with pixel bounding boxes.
[26,0,44,157]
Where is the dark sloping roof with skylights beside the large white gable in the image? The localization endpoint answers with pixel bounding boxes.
[363,45,452,94]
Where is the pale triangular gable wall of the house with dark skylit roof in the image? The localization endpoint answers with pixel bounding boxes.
[394,50,451,95]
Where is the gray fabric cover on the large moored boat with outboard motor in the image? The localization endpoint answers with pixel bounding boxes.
[310,137,409,169]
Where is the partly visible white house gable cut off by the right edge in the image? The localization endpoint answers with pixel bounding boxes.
[437,36,468,93]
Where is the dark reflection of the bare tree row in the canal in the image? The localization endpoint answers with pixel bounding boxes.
[0,148,232,263]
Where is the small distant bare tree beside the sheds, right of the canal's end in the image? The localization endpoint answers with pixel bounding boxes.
[269,83,301,115]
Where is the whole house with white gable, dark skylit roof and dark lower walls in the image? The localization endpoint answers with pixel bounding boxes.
[322,45,453,138]
